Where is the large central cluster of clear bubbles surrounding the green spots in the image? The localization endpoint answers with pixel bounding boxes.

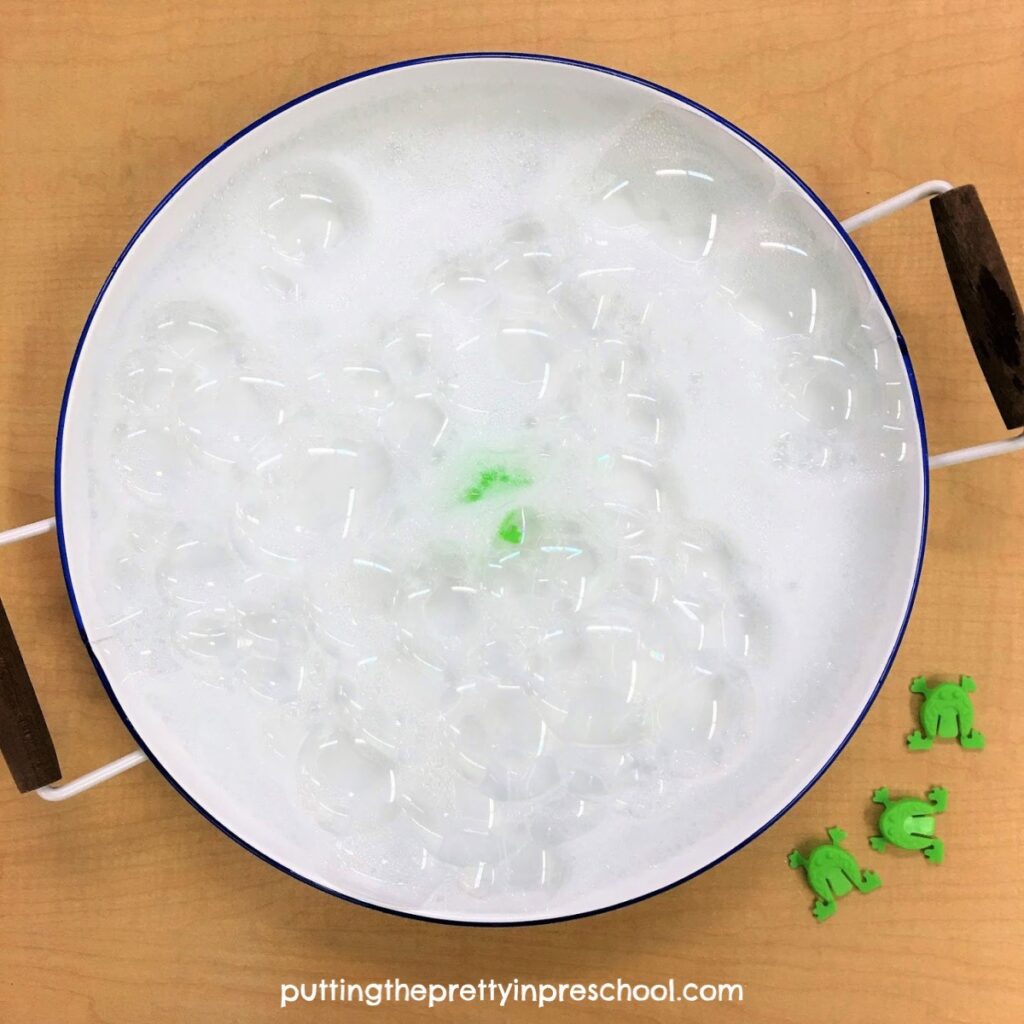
[97,200,764,898]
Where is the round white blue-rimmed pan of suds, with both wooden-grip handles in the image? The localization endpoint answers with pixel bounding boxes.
[0,54,1024,924]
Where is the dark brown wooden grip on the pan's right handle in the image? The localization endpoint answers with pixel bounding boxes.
[932,185,1024,429]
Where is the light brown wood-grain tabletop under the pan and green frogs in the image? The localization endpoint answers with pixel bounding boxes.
[0,0,1024,1024]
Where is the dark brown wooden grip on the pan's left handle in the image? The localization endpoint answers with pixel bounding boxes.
[0,601,60,793]
